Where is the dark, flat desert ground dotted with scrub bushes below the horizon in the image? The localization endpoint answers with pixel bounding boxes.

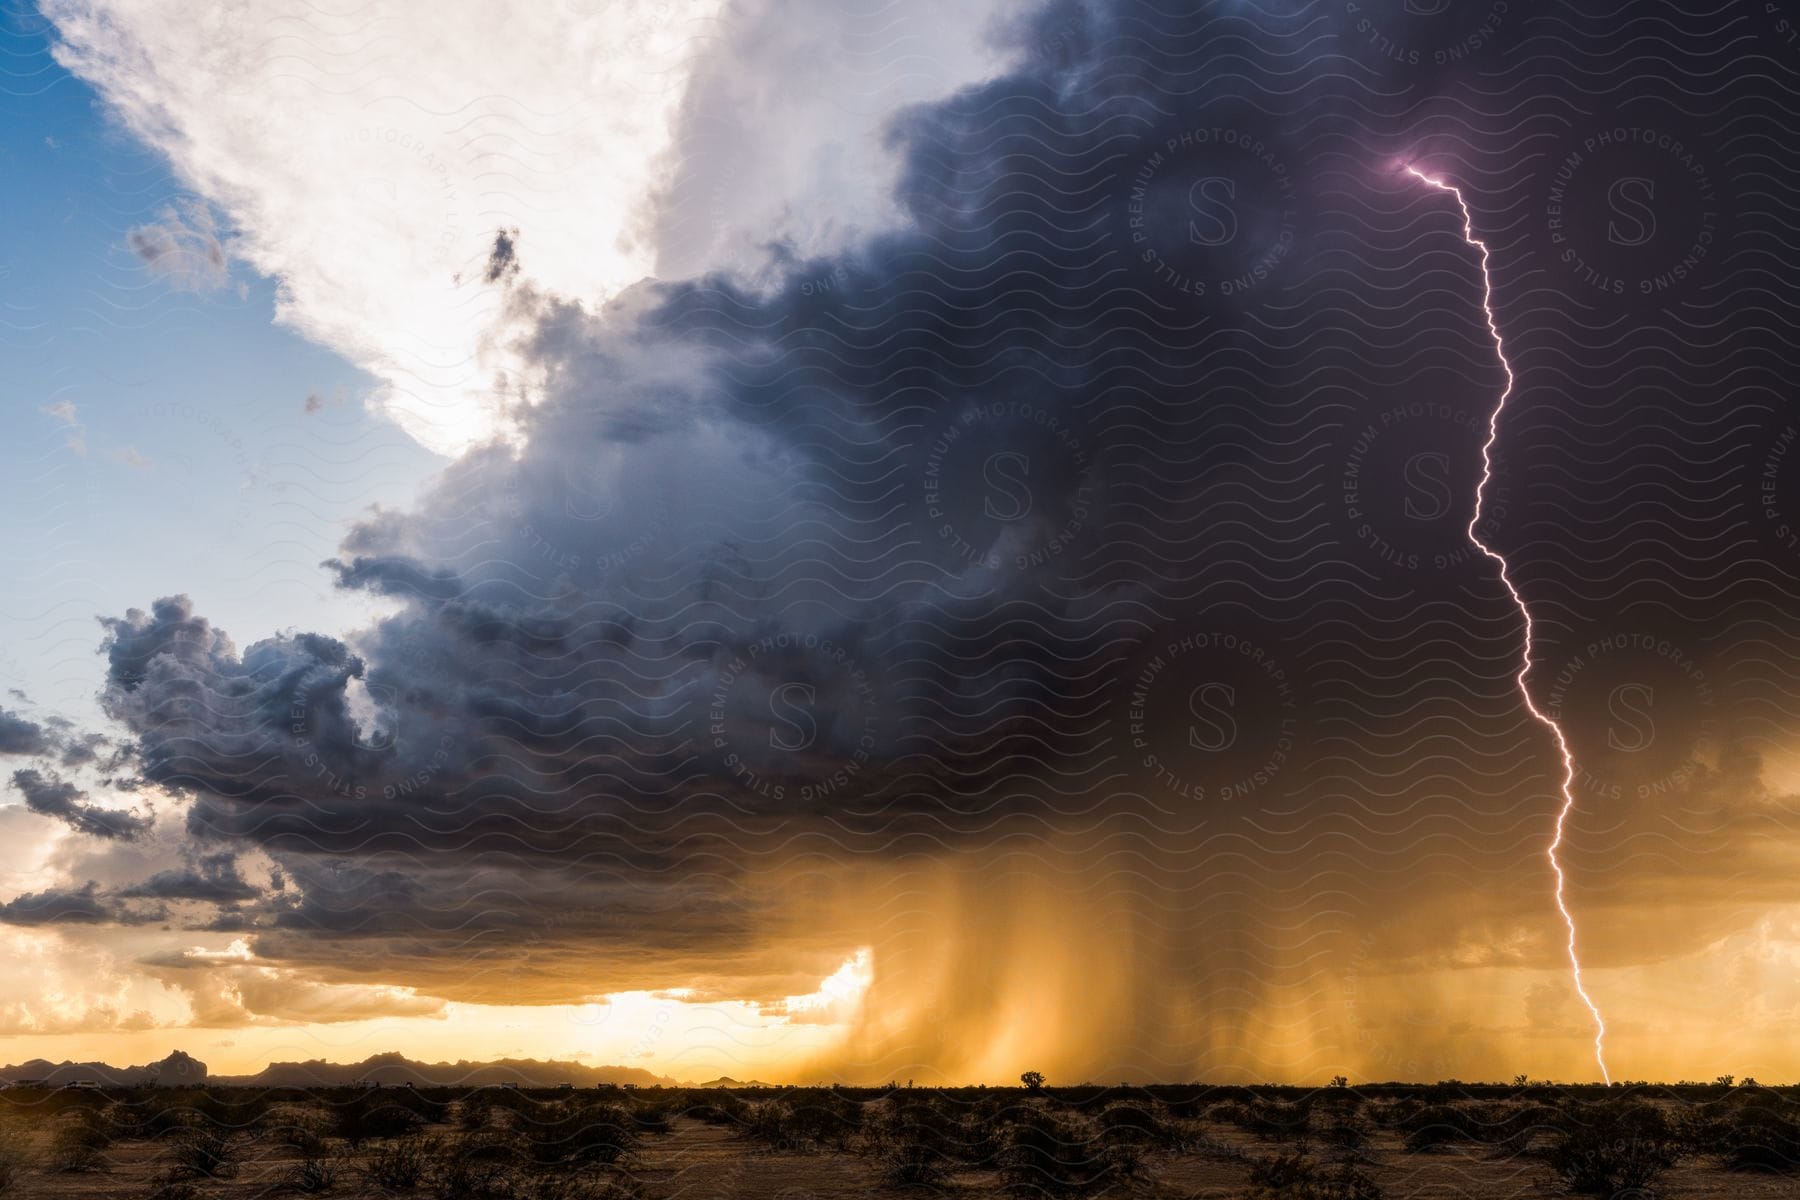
[0,1083,1800,1200]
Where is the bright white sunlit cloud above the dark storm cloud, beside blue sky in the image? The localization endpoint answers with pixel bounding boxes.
[45,0,724,453]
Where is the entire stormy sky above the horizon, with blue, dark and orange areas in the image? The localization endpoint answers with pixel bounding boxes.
[0,0,1800,1083]
